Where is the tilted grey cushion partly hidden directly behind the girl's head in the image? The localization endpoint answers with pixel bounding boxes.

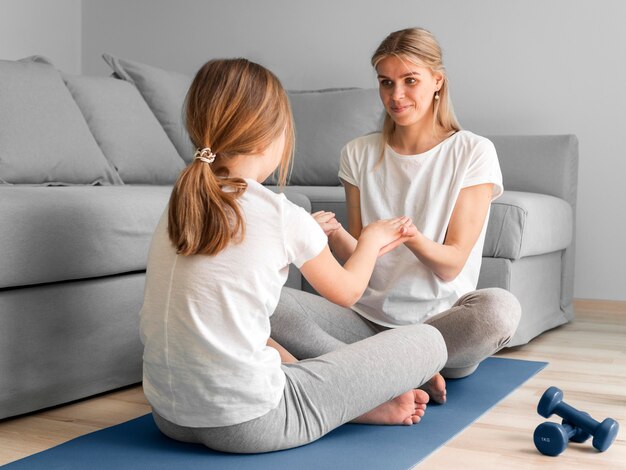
[102,54,195,163]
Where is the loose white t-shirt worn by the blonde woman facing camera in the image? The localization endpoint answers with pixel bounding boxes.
[339,131,503,327]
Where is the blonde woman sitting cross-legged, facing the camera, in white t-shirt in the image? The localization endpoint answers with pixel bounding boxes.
[272,28,521,403]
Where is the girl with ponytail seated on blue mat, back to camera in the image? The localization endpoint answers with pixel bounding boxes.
[141,59,446,452]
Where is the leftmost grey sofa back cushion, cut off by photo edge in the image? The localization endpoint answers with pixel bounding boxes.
[0,58,122,185]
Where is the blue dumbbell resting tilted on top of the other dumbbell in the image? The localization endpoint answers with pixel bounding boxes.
[537,387,619,452]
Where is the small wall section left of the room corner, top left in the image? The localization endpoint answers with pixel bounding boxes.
[0,0,82,73]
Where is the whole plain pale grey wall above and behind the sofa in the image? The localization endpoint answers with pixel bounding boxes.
[7,0,626,300]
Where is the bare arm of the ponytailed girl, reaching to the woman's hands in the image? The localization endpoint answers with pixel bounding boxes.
[300,217,412,307]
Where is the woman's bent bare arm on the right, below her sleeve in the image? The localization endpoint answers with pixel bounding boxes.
[405,183,493,282]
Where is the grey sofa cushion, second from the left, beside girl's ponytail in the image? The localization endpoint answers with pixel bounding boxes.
[63,74,185,184]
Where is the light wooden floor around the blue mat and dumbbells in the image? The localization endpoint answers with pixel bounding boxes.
[0,300,626,470]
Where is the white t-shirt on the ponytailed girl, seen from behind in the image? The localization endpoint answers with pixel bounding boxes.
[140,180,328,427]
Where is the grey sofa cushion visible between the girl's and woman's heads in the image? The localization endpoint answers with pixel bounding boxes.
[288,89,384,186]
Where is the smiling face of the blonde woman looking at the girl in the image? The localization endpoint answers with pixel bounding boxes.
[376,56,443,131]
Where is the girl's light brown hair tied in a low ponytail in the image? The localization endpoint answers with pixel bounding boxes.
[168,59,294,256]
